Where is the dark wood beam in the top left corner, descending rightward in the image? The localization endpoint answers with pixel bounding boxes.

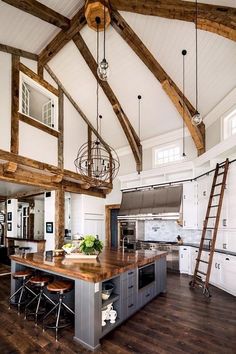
[3,0,70,30]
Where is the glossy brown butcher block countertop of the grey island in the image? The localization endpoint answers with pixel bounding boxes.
[10,248,167,283]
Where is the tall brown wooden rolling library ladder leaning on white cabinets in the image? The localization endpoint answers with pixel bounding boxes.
[189,159,229,297]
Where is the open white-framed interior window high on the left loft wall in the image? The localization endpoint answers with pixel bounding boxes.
[19,73,58,130]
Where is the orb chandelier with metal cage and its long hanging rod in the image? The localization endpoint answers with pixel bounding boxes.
[74,17,120,186]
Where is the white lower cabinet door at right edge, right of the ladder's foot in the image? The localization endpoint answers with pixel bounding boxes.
[221,255,236,296]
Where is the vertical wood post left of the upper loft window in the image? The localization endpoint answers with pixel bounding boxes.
[11,54,20,154]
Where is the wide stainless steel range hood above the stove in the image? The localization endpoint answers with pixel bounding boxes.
[119,185,183,219]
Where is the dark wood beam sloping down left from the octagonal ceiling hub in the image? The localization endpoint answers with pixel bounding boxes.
[39,7,86,66]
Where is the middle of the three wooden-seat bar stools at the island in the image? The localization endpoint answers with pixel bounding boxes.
[24,276,56,326]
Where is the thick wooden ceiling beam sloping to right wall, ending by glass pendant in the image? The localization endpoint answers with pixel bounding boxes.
[111,11,205,152]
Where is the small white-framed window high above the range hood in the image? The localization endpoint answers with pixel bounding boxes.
[153,144,181,166]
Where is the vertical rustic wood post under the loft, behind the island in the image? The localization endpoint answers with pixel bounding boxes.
[55,188,65,249]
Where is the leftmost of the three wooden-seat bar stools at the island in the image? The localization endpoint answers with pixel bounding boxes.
[9,270,36,315]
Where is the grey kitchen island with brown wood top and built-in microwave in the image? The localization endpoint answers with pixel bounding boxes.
[11,248,166,350]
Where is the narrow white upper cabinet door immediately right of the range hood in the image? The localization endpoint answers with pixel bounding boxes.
[183,182,197,229]
